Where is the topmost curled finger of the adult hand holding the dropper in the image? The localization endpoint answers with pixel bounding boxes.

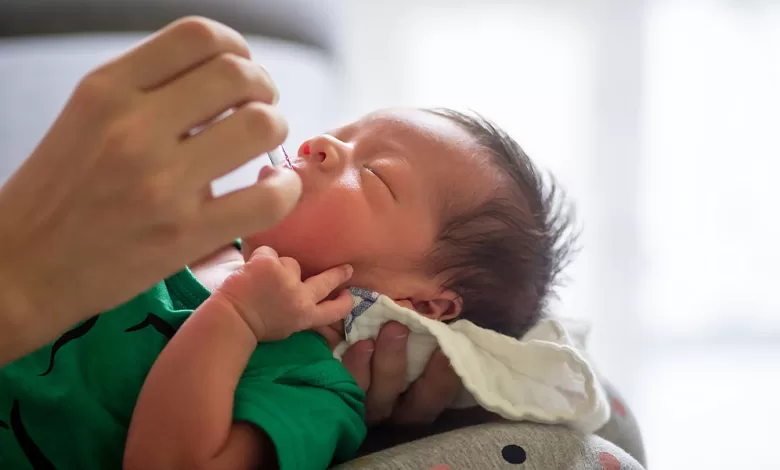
[112,16,250,91]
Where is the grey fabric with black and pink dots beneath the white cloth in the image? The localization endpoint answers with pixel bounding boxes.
[336,381,646,470]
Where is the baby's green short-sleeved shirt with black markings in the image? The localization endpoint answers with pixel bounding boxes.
[0,269,366,470]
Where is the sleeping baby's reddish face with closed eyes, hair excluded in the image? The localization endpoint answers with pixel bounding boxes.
[244,109,495,300]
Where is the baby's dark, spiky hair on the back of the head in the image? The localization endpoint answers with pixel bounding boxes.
[427,109,578,338]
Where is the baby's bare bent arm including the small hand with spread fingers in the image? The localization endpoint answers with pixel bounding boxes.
[124,247,354,470]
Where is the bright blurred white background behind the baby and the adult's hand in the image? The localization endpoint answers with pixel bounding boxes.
[0,0,780,470]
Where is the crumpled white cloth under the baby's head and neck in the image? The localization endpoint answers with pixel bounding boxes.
[334,289,610,433]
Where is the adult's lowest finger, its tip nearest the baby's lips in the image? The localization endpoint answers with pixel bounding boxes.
[195,167,301,241]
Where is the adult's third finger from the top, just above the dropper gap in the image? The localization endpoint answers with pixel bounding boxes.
[181,101,287,188]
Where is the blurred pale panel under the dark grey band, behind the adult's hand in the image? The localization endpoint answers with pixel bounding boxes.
[0,33,343,184]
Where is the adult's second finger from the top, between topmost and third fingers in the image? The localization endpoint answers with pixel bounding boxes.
[152,53,278,135]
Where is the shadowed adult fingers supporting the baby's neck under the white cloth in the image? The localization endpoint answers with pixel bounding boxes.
[342,322,461,425]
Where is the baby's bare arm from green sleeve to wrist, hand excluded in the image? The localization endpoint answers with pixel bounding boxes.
[124,296,275,470]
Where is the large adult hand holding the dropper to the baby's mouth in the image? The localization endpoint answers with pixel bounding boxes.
[0,18,301,364]
